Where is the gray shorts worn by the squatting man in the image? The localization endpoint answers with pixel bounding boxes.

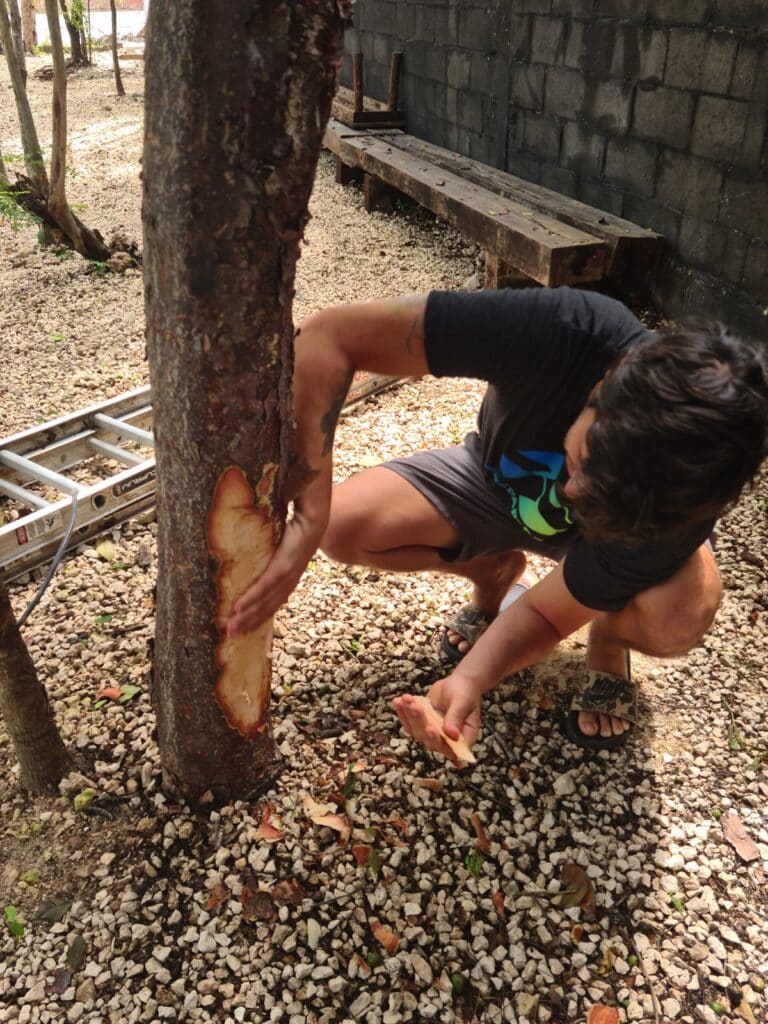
[384,432,567,562]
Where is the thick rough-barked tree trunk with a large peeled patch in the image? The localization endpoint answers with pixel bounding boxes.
[143,0,347,803]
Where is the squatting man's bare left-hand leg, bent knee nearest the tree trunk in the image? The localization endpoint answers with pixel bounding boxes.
[321,466,525,615]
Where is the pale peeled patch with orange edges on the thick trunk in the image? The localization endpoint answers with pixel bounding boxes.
[206,464,278,737]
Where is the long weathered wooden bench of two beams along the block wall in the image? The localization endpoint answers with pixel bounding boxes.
[324,119,662,288]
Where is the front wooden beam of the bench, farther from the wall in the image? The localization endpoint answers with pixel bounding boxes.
[324,121,607,287]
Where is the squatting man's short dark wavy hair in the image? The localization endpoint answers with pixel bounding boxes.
[569,321,768,544]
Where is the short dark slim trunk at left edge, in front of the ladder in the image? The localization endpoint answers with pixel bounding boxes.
[0,583,70,796]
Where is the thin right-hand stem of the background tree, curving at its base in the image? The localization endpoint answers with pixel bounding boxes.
[43,0,111,260]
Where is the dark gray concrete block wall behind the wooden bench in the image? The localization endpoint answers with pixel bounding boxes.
[342,0,768,338]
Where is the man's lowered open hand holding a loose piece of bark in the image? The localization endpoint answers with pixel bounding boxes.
[392,675,480,764]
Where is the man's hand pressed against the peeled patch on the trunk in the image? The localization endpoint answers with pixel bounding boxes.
[226,509,325,637]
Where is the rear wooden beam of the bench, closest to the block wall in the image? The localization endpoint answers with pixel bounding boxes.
[381,132,662,276]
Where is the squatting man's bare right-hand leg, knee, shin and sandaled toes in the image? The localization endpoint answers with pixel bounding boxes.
[579,545,722,736]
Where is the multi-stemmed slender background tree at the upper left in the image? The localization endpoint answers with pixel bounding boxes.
[0,0,112,261]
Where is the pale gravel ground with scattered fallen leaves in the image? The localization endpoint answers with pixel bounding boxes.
[0,58,768,1024]
